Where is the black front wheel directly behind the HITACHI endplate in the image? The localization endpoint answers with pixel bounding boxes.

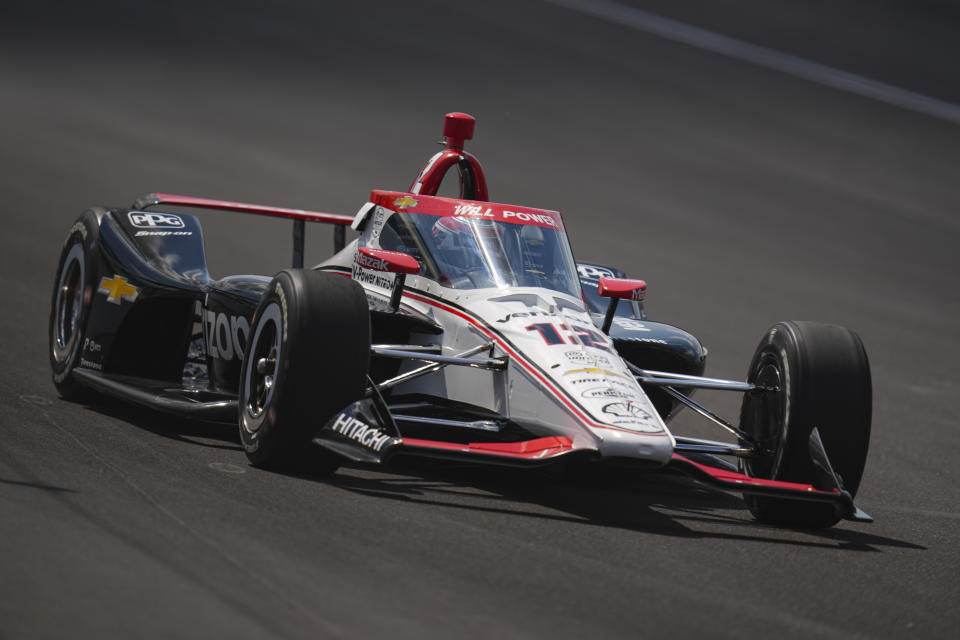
[239,269,370,474]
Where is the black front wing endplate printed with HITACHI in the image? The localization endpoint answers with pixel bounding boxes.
[313,398,403,464]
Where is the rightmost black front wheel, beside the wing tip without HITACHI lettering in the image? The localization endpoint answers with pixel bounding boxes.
[740,321,872,527]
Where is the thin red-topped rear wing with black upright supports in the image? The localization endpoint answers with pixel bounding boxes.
[130,193,354,269]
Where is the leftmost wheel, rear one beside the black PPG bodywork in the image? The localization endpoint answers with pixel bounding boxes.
[47,211,100,401]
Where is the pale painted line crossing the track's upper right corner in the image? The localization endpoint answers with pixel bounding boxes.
[545,0,960,124]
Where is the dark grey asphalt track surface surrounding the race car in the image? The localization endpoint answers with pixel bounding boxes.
[0,1,960,638]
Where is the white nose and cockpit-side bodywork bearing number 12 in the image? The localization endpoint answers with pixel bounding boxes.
[318,199,675,464]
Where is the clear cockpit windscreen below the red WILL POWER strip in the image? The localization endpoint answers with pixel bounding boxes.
[379,211,580,298]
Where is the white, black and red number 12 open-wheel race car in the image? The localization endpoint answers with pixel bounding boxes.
[49,113,872,527]
